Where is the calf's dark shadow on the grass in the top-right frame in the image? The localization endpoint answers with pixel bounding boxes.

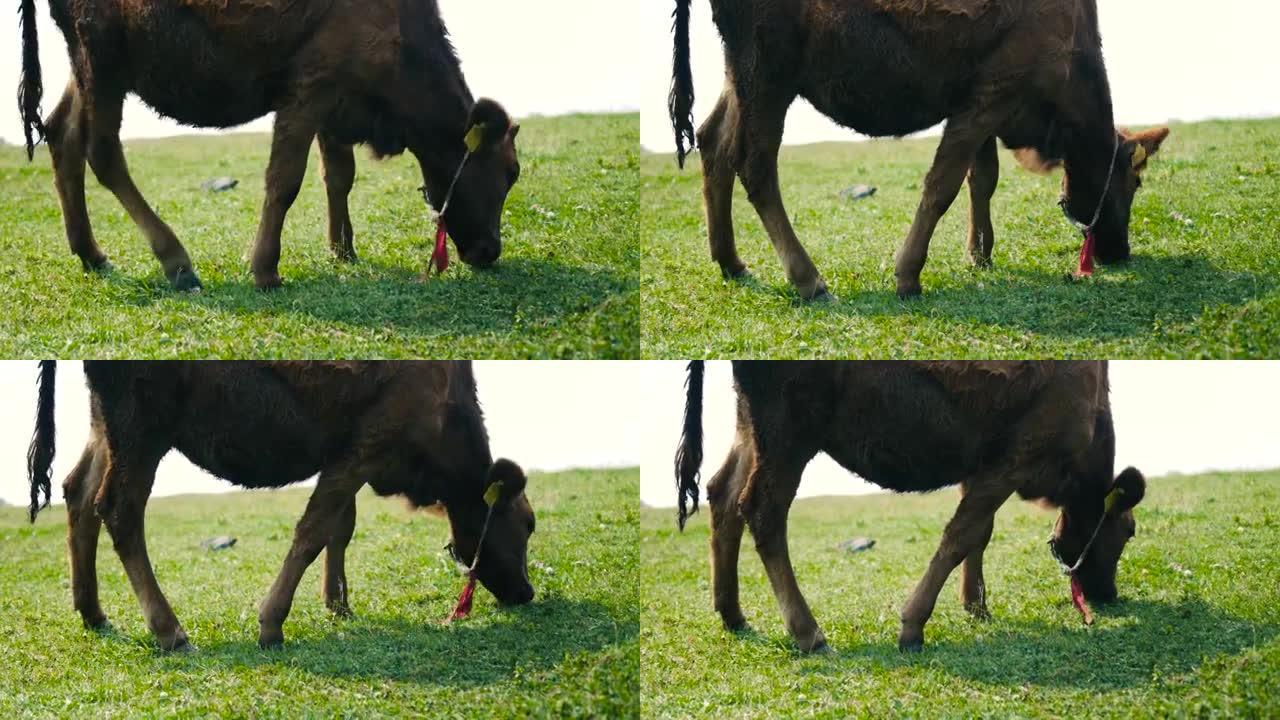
[798,255,1277,338]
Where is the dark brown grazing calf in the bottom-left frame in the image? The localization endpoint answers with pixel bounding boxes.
[32,361,534,650]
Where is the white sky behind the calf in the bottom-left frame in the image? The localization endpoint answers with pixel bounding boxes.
[0,360,643,506]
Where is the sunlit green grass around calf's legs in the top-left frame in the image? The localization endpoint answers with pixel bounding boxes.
[0,114,640,359]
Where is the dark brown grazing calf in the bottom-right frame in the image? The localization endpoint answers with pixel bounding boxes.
[677,361,1146,651]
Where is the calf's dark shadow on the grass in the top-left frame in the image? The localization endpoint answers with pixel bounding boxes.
[108,258,639,336]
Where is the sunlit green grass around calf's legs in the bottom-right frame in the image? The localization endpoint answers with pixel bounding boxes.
[640,471,1280,717]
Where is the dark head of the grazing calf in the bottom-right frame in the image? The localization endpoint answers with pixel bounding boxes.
[1051,468,1147,602]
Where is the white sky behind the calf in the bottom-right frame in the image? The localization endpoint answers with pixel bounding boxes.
[640,361,1280,507]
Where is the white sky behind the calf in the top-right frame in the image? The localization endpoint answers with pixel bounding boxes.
[639,0,1280,152]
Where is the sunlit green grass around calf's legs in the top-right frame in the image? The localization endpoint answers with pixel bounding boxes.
[639,119,1280,359]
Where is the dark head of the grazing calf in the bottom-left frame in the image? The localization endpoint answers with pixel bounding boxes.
[448,460,534,605]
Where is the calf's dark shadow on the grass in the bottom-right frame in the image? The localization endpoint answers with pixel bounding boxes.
[797,598,1280,692]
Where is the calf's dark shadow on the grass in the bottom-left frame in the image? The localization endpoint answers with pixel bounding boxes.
[175,598,640,687]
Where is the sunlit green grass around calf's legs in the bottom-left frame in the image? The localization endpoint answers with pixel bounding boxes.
[0,469,639,717]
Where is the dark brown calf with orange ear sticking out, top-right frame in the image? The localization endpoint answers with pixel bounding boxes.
[668,0,1167,297]
